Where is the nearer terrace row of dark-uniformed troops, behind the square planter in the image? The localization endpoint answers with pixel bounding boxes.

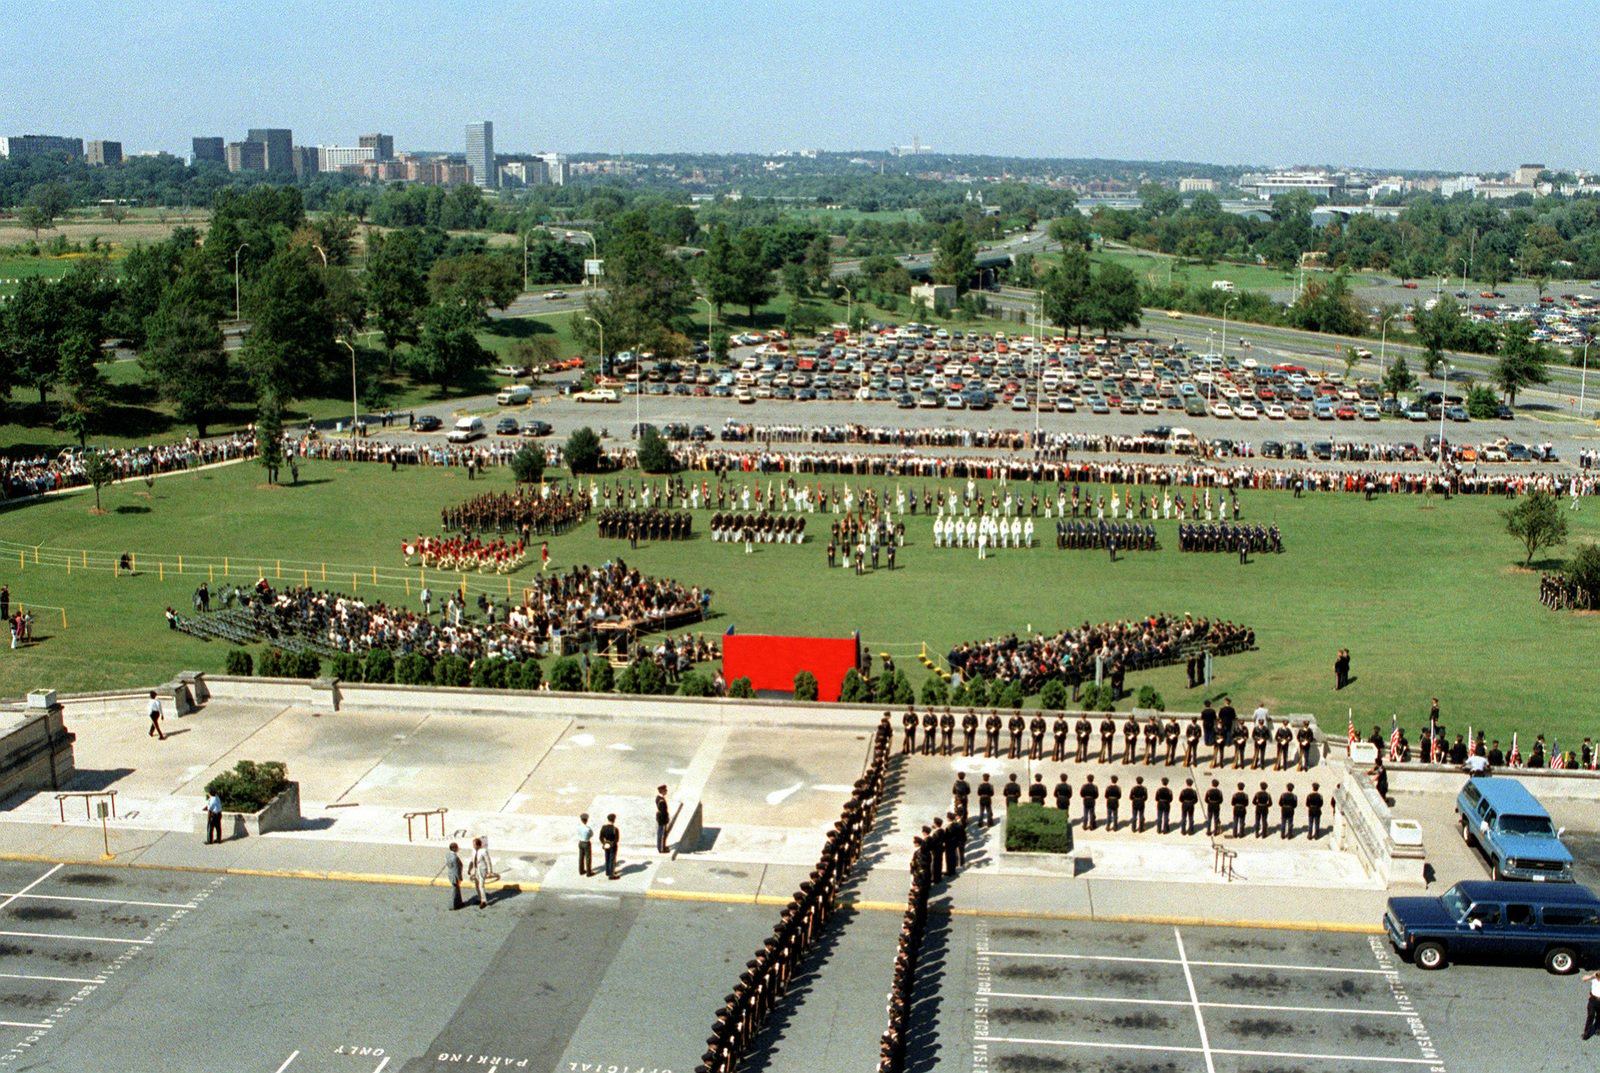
[950,771,1326,840]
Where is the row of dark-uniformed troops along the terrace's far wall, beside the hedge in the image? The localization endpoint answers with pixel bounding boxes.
[901,704,1317,771]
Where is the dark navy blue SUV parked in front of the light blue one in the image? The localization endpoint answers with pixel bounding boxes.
[1384,880,1600,975]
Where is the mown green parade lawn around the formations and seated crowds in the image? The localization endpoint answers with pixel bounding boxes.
[0,462,1600,745]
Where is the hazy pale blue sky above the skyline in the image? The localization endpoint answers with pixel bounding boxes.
[0,0,1600,171]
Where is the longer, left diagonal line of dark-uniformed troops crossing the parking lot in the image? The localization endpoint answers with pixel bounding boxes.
[694,712,893,1073]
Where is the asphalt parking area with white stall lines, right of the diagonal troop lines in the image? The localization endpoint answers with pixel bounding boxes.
[912,916,1590,1073]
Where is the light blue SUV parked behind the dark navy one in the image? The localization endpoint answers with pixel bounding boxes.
[1456,777,1573,883]
